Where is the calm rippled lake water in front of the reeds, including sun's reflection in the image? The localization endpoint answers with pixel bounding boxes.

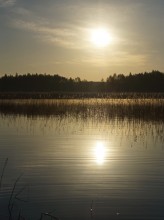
[0,99,164,220]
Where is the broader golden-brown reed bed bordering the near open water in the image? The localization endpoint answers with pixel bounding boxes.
[0,98,164,121]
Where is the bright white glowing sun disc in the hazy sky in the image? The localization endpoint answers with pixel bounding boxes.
[90,28,112,48]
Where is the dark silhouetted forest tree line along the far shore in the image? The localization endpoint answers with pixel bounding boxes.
[0,70,164,93]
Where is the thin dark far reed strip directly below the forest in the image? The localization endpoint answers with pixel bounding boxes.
[0,92,164,99]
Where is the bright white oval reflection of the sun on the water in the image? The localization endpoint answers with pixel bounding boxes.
[94,141,106,165]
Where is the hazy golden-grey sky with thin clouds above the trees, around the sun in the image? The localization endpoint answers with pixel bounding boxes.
[0,0,164,81]
